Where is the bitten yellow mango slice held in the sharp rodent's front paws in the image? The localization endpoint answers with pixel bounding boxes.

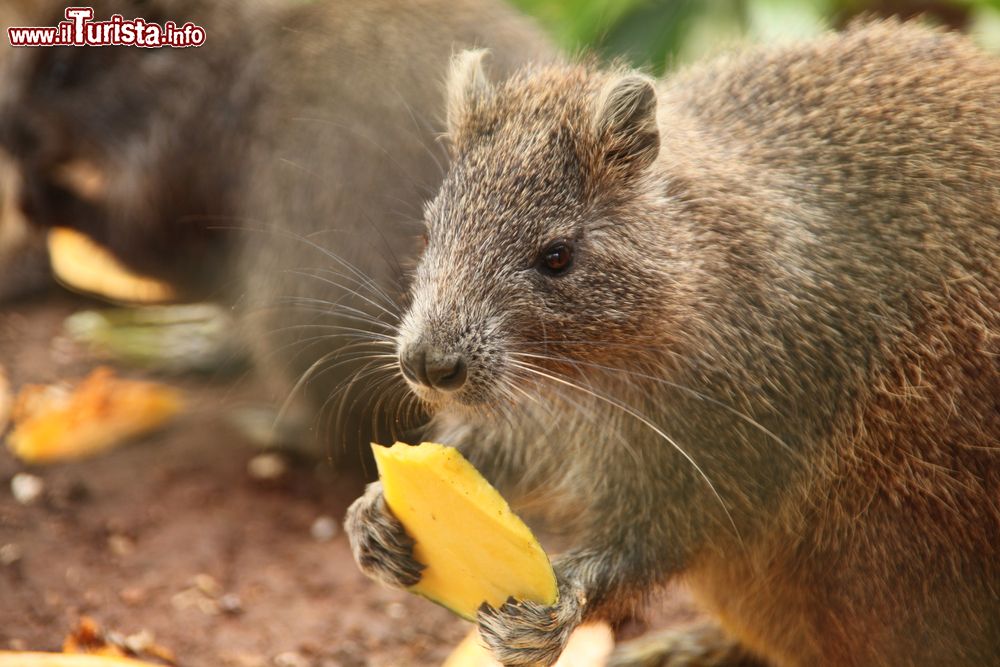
[372,442,558,620]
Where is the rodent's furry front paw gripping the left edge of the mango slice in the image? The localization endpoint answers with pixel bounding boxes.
[344,482,424,588]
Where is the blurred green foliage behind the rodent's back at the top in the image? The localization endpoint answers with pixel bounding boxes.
[514,0,1000,73]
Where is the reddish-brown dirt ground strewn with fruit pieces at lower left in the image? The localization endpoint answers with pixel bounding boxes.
[0,292,685,667]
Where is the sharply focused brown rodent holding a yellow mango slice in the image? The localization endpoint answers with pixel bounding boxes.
[347,22,1000,667]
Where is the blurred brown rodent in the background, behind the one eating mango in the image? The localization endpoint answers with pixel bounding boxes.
[0,0,549,454]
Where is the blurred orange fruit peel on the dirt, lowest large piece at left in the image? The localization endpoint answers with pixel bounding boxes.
[7,368,183,463]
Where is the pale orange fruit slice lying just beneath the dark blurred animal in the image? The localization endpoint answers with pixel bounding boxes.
[48,227,176,303]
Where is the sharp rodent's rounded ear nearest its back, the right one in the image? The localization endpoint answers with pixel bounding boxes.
[594,74,660,176]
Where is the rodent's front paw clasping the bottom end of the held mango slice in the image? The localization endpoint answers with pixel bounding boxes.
[477,586,585,667]
